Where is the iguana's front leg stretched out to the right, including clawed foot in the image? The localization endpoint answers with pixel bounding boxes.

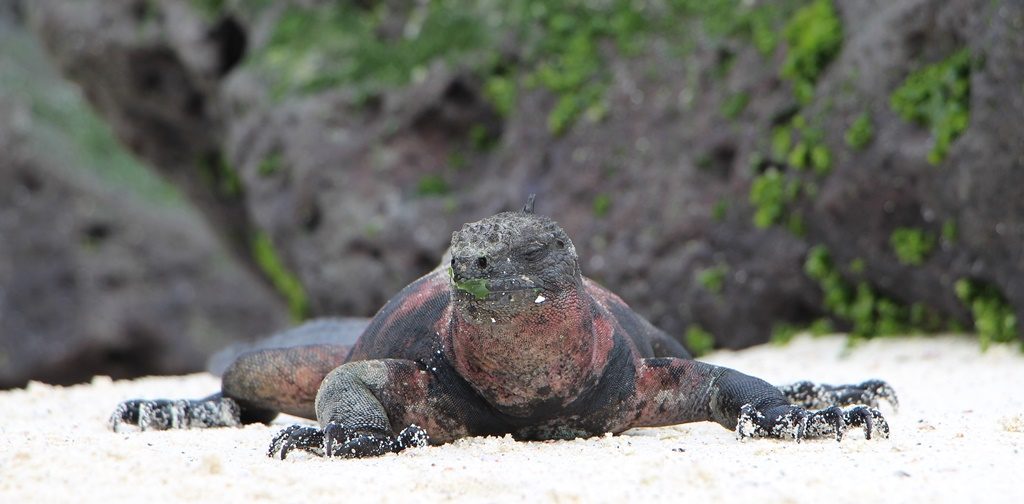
[630,359,889,440]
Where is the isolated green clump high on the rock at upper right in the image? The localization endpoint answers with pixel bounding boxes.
[890,49,971,165]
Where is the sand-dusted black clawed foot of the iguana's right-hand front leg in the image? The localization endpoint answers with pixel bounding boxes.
[736,405,889,442]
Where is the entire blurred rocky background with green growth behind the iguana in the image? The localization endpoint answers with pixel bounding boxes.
[0,0,1024,387]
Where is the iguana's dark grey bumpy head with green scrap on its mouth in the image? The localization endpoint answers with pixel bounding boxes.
[451,199,583,324]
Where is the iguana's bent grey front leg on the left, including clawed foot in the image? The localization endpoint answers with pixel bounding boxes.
[267,359,468,459]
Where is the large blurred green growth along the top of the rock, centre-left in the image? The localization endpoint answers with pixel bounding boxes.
[252,0,648,134]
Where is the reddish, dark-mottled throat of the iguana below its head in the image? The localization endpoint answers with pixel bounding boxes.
[445,286,611,417]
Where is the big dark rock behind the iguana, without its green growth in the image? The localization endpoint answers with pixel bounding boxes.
[19,0,1024,358]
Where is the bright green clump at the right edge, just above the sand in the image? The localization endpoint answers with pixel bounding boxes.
[954,279,1018,349]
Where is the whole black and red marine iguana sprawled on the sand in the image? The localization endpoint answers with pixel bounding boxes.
[111,197,897,459]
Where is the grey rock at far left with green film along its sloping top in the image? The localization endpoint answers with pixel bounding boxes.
[0,11,287,388]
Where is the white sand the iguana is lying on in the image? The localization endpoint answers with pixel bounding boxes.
[0,337,1024,504]
